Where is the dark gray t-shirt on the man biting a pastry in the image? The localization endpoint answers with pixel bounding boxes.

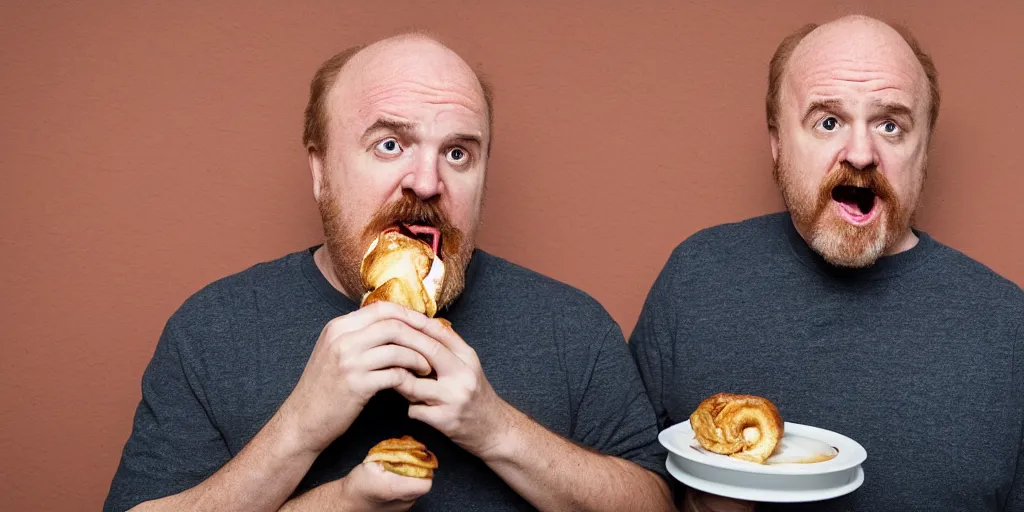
[103,249,665,511]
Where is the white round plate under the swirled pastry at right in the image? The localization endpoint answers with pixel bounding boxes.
[658,421,867,503]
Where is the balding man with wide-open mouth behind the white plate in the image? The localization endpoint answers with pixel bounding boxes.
[630,16,1024,512]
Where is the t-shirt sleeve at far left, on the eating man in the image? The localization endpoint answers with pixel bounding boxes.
[103,317,230,512]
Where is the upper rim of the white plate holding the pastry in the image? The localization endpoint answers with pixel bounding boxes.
[657,420,867,475]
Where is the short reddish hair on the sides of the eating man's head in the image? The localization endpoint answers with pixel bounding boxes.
[302,38,494,153]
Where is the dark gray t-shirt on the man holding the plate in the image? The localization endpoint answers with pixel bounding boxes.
[630,214,1024,512]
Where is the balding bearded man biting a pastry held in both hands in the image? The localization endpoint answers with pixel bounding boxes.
[104,34,672,512]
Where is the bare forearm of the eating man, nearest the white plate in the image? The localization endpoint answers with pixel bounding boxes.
[483,411,673,511]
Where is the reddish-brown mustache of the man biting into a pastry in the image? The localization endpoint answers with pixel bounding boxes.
[364,190,464,255]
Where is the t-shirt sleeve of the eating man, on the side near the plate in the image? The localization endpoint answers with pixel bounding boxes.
[570,318,668,478]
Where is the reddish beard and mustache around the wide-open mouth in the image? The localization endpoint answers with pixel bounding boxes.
[772,155,913,268]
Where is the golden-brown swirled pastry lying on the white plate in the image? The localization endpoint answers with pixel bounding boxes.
[690,393,782,464]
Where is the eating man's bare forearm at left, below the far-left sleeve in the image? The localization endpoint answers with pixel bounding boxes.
[132,412,317,512]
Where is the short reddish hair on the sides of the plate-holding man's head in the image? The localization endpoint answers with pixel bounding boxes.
[765,24,942,131]
